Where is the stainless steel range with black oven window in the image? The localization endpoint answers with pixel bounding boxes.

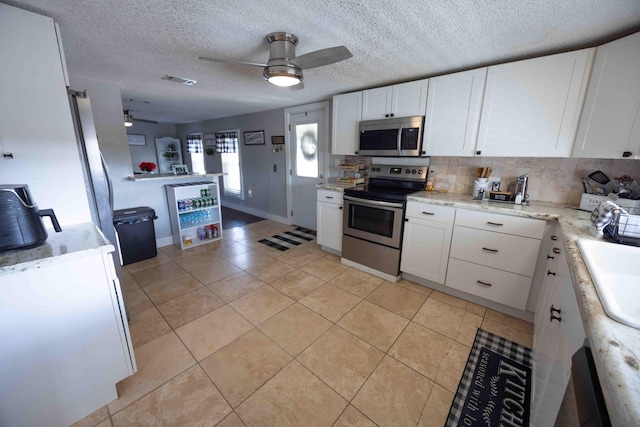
[342,158,429,279]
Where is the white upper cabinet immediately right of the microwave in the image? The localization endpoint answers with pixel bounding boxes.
[423,68,487,156]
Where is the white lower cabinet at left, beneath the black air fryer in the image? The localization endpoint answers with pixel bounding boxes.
[0,251,136,426]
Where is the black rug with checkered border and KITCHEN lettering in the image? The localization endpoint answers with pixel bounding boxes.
[445,328,532,427]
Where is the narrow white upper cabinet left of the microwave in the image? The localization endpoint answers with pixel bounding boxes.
[331,92,362,156]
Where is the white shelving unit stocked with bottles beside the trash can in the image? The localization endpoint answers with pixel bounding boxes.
[165,182,222,249]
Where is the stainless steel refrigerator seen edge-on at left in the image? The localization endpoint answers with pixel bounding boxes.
[68,89,129,319]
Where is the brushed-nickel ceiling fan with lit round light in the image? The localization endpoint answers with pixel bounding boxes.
[200,32,353,87]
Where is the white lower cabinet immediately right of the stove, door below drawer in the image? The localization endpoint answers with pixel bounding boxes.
[400,201,456,284]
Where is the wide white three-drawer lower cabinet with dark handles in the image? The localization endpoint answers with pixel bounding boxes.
[445,209,546,310]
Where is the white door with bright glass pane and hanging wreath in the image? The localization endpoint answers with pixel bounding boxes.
[285,103,329,230]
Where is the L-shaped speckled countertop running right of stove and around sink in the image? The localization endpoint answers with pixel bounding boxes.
[408,191,640,426]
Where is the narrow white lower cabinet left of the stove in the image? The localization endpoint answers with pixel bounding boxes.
[316,190,343,253]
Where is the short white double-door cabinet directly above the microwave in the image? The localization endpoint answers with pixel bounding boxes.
[362,79,429,120]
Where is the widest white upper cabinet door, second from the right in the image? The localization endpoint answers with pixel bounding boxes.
[476,49,592,157]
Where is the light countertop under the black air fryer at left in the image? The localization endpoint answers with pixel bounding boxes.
[0,222,115,275]
